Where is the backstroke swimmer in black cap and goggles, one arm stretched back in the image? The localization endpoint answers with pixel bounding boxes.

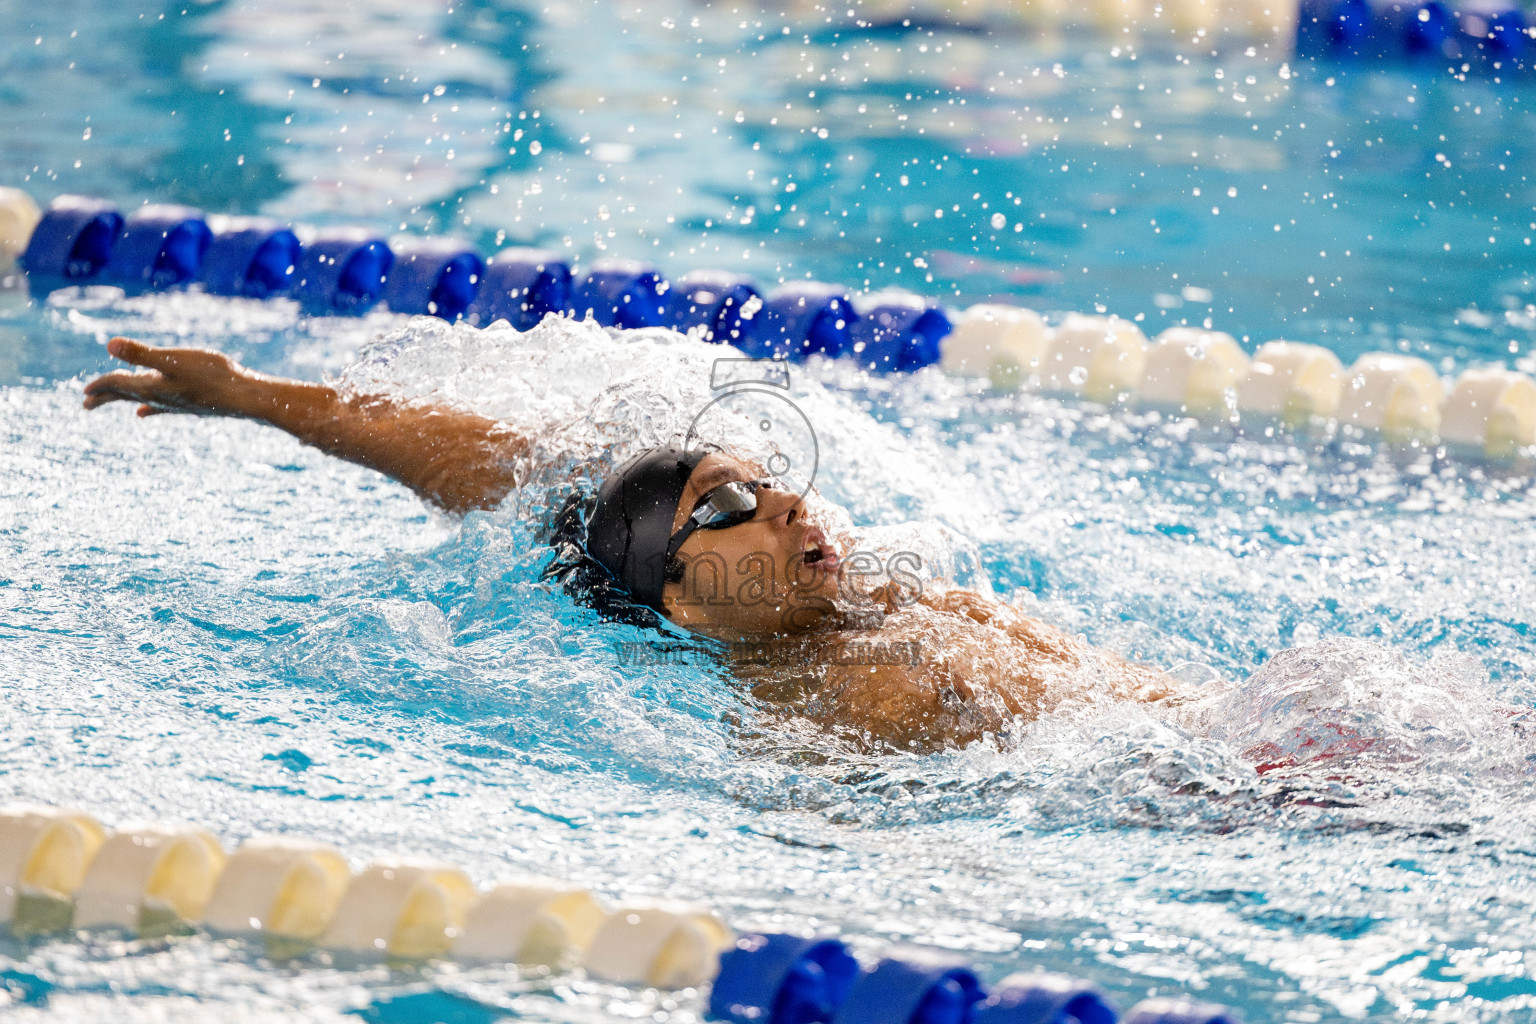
[84,338,1180,751]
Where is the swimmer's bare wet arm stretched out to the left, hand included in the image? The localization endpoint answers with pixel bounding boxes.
[84,338,528,513]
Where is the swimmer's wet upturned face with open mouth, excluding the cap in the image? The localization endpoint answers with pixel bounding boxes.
[662,451,840,640]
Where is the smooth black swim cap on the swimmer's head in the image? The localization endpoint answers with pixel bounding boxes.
[587,445,711,611]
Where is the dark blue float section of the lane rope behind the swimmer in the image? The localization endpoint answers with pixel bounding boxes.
[22,195,952,373]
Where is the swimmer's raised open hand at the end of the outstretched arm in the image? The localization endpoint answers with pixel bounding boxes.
[84,338,253,416]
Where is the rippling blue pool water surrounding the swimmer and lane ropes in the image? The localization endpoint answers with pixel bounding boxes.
[0,0,1536,1021]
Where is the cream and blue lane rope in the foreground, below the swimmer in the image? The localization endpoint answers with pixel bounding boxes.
[0,806,1236,1024]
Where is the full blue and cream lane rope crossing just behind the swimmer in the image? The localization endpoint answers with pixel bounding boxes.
[0,189,1536,461]
